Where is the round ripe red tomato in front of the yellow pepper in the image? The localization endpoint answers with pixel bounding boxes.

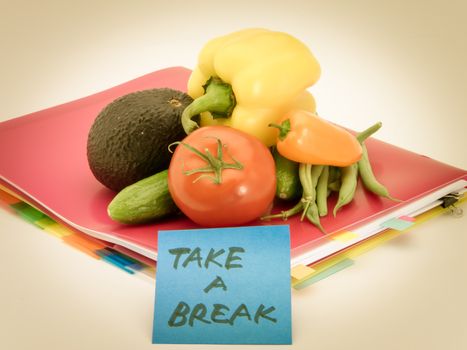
[168,126,276,227]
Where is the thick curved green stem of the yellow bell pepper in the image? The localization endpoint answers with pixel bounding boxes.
[182,77,236,134]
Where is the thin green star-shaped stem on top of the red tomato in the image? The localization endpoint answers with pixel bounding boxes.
[169,138,243,185]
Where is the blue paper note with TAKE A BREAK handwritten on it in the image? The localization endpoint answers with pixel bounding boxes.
[152,225,292,344]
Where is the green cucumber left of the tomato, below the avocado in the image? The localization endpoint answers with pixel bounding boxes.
[107,170,178,224]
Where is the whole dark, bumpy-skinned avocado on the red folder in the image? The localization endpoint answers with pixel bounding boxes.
[87,88,193,192]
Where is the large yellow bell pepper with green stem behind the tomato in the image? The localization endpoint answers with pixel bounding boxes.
[182,29,320,146]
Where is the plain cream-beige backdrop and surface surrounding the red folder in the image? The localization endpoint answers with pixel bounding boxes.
[0,0,467,349]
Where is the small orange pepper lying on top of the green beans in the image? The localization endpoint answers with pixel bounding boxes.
[270,110,362,167]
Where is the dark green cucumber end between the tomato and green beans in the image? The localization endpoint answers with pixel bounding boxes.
[273,149,302,200]
